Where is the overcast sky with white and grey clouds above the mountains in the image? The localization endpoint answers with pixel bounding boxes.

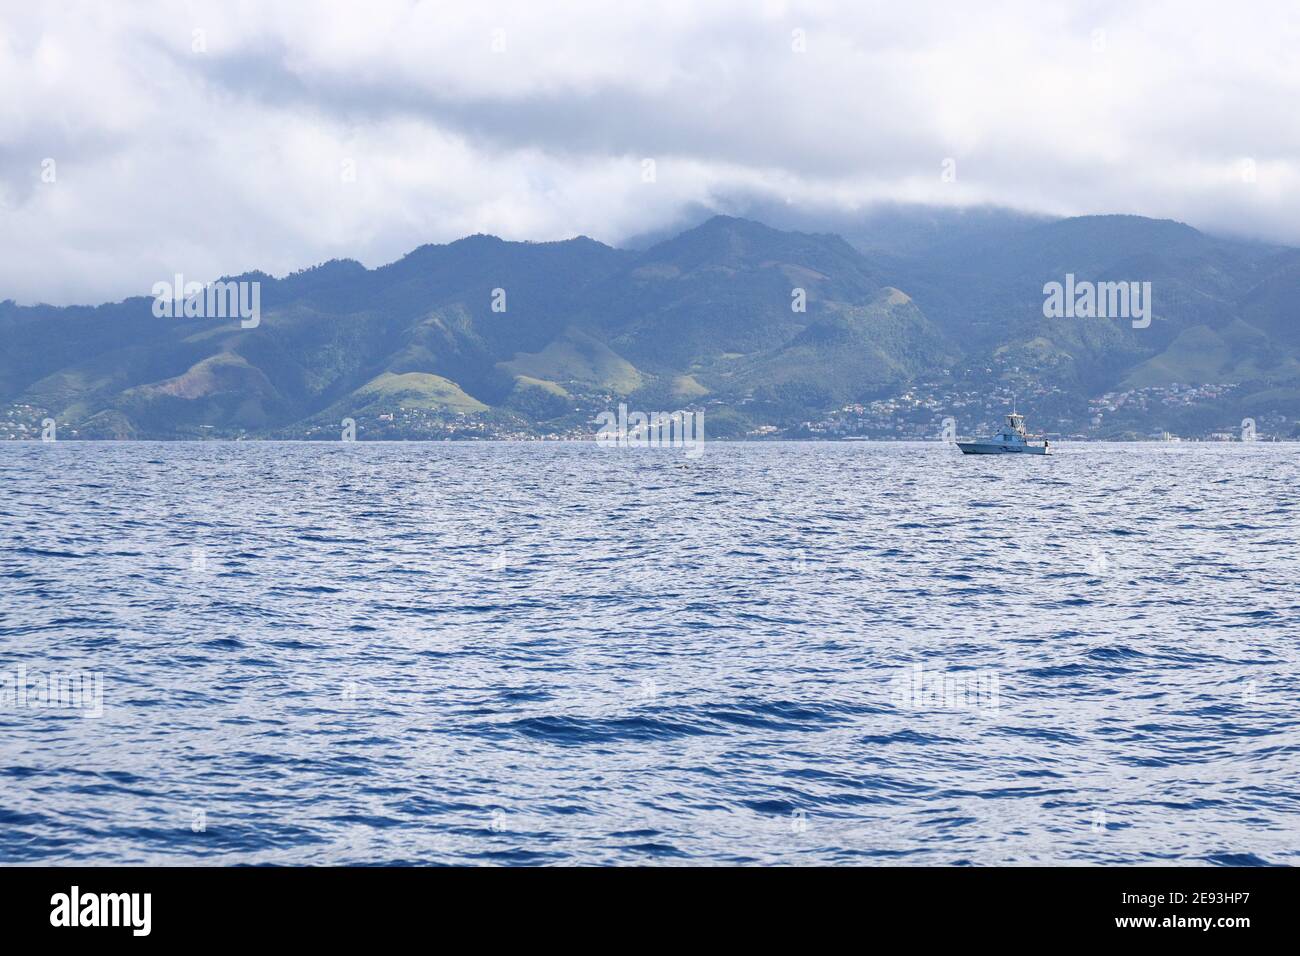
[0,0,1300,304]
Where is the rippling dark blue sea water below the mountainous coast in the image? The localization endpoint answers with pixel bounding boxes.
[0,442,1300,865]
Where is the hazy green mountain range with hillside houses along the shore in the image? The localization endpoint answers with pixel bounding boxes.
[0,212,1300,438]
